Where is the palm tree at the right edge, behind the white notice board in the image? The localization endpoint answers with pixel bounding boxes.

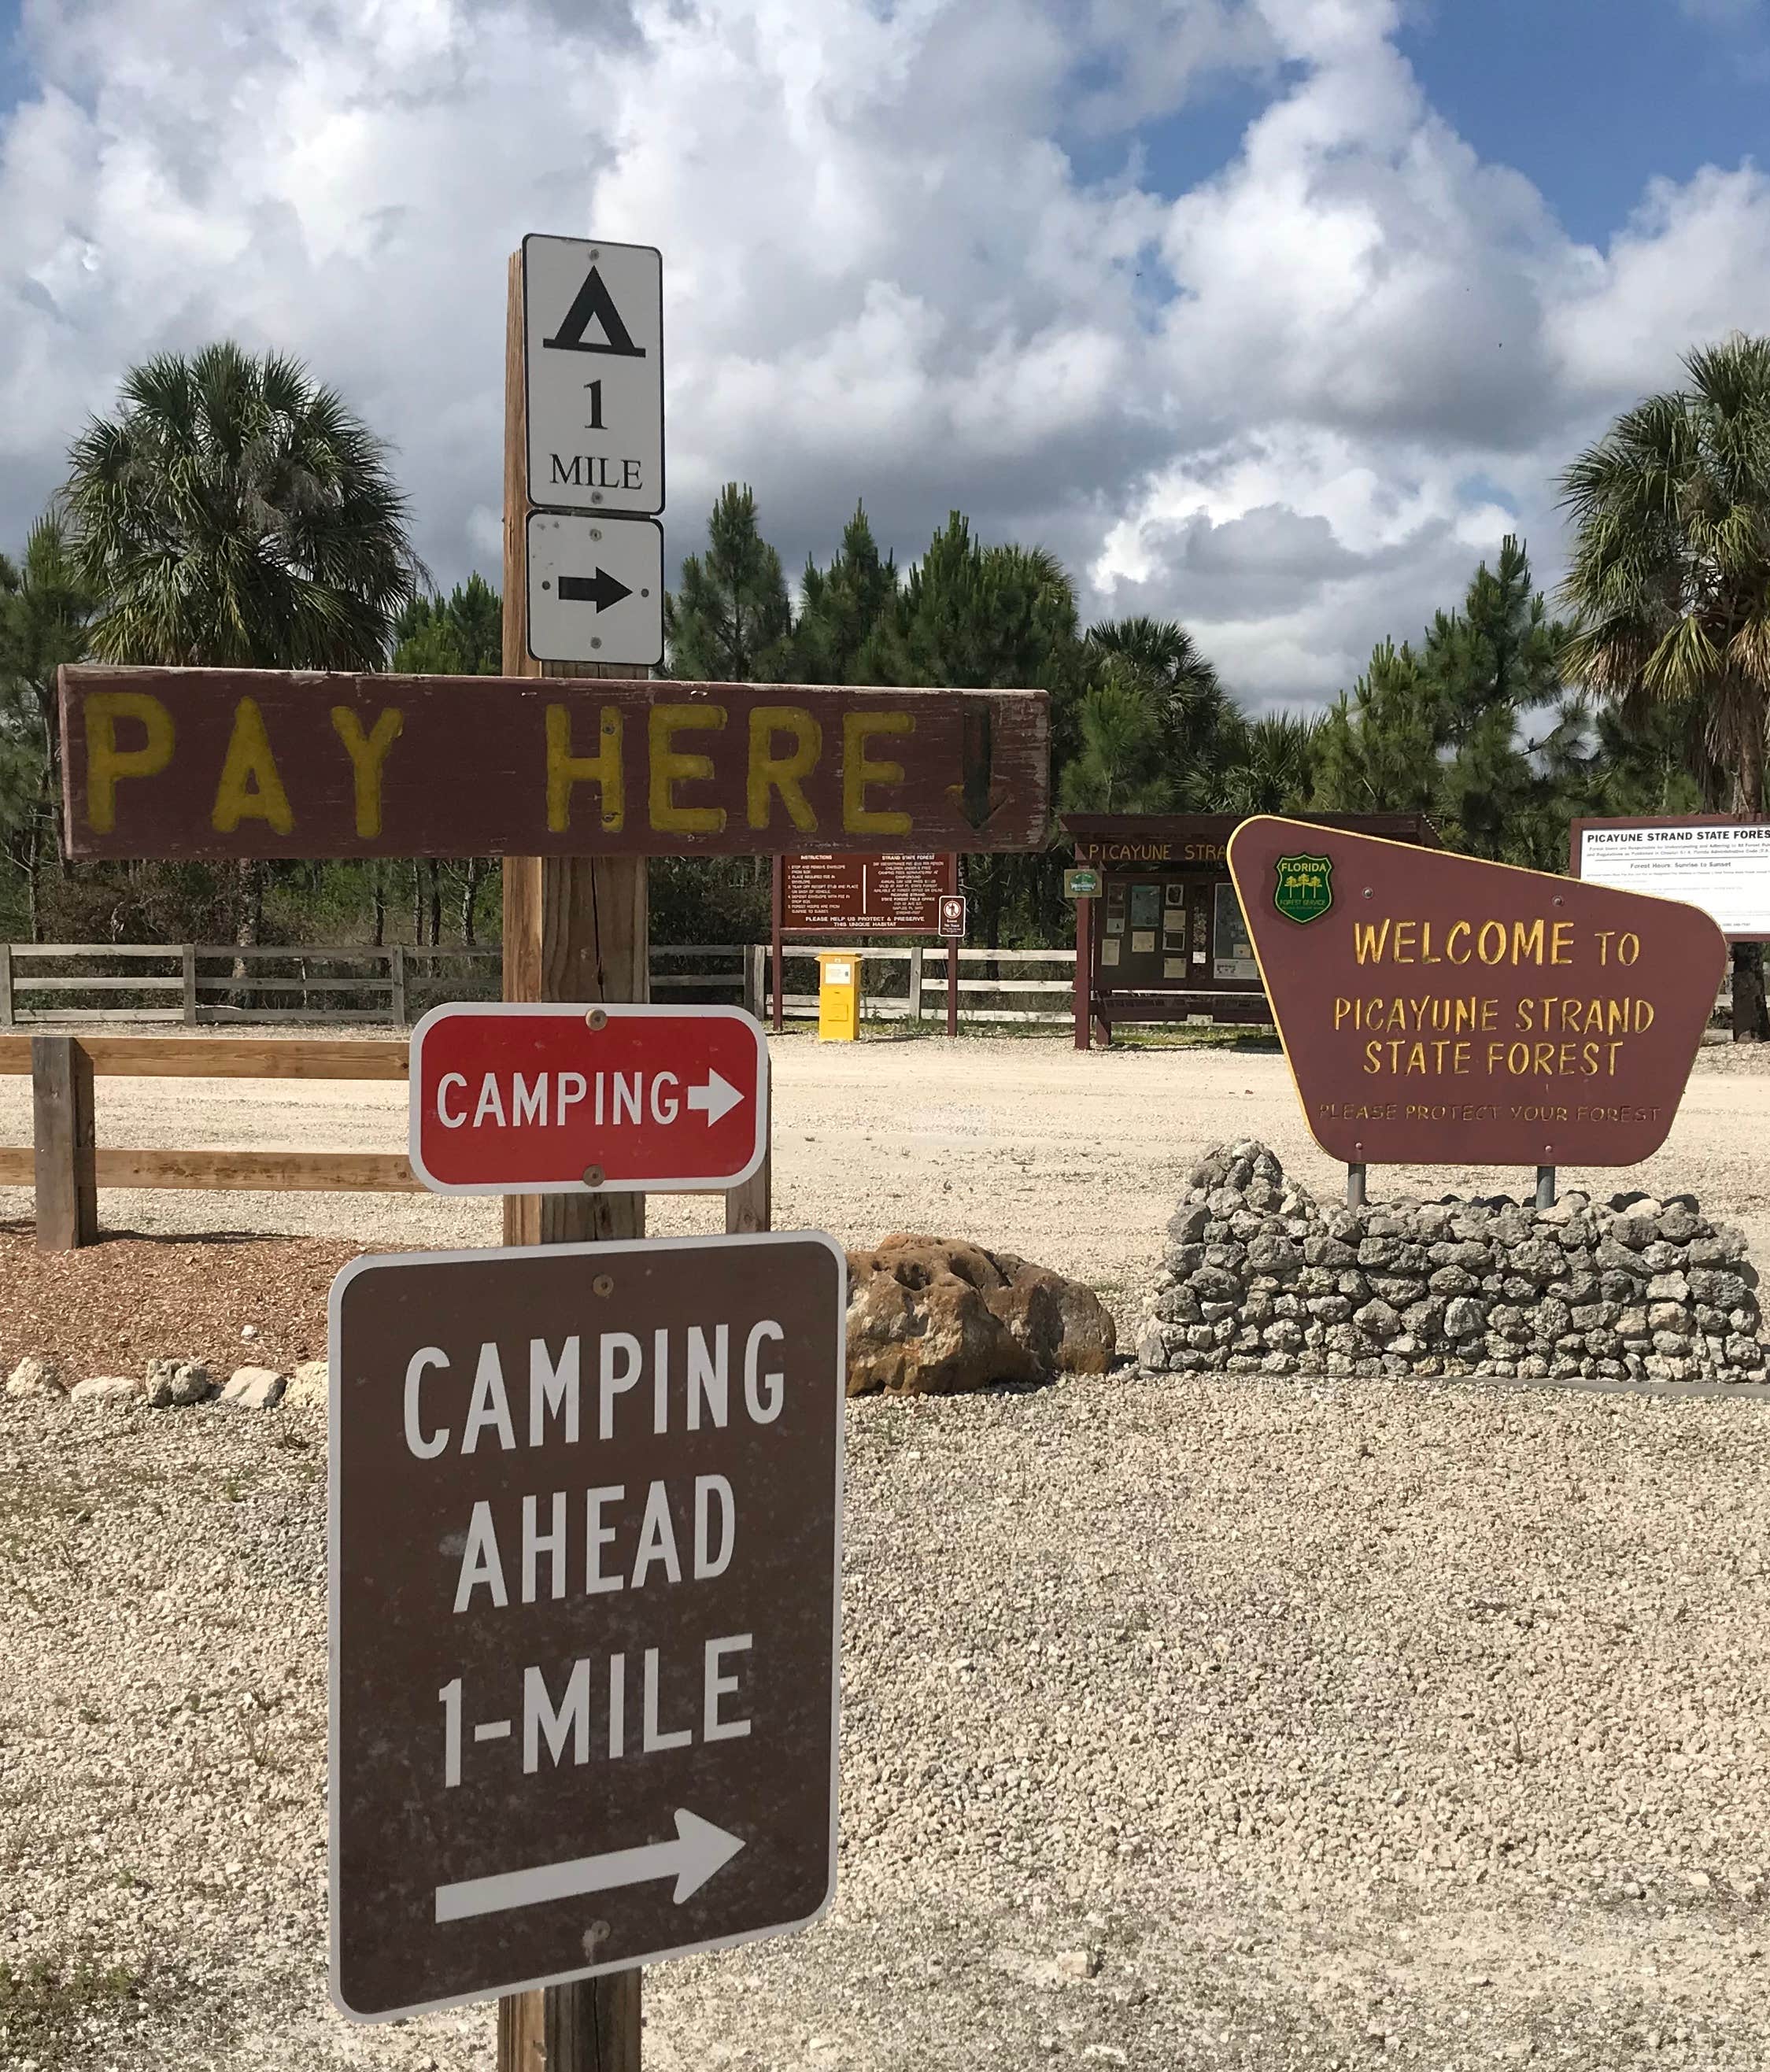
[1561,331,1770,1036]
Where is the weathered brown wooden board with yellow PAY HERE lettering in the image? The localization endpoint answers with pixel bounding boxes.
[60,665,1049,858]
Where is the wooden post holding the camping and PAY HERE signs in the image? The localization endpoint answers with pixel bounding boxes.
[497,235,651,2072]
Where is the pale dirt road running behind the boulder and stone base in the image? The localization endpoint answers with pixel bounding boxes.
[0,1034,1770,1289]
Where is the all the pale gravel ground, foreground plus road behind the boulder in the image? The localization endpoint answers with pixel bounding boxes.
[0,1040,1770,2072]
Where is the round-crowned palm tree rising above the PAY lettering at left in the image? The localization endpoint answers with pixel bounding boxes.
[62,342,425,669]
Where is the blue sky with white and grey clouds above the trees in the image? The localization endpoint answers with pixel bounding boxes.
[0,0,1770,704]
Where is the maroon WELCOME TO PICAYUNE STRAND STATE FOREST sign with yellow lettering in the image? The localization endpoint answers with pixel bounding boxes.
[1229,816,1727,1165]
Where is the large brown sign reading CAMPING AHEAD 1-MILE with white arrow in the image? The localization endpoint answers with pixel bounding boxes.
[330,1231,845,2020]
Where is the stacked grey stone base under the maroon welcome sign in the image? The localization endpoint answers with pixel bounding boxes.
[1138,1139,1766,1382]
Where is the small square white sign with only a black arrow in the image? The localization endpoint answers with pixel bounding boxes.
[529,512,663,669]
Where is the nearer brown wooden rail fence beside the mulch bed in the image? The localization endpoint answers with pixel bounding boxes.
[0,1036,769,1251]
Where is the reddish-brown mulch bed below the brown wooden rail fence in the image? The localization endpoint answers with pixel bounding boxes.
[0,1222,395,1380]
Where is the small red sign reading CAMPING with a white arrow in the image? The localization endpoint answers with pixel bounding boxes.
[408,1001,769,1194]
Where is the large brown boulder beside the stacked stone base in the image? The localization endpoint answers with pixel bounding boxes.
[848,1233,1117,1397]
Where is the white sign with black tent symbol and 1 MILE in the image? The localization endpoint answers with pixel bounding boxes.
[523,235,663,518]
